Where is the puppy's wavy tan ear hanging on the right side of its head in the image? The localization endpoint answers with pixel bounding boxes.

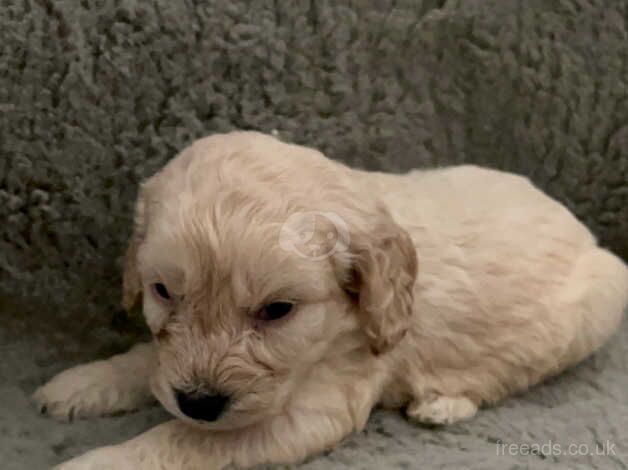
[341,208,418,355]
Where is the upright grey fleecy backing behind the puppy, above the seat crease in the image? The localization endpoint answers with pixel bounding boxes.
[0,0,628,325]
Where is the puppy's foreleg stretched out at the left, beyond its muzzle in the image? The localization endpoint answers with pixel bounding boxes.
[33,343,155,420]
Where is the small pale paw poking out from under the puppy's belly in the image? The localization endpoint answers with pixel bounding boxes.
[407,396,478,424]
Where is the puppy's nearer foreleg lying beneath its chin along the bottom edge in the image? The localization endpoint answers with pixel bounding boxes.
[58,370,380,470]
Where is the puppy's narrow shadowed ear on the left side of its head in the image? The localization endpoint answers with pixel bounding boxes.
[122,187,147,312]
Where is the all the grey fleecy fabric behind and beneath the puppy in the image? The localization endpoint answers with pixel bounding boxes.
[0,0,628,469]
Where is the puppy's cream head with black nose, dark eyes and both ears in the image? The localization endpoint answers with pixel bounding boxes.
[123,133,417,429]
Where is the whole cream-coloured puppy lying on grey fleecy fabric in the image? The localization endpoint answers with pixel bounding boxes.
[35,132,628,470]
